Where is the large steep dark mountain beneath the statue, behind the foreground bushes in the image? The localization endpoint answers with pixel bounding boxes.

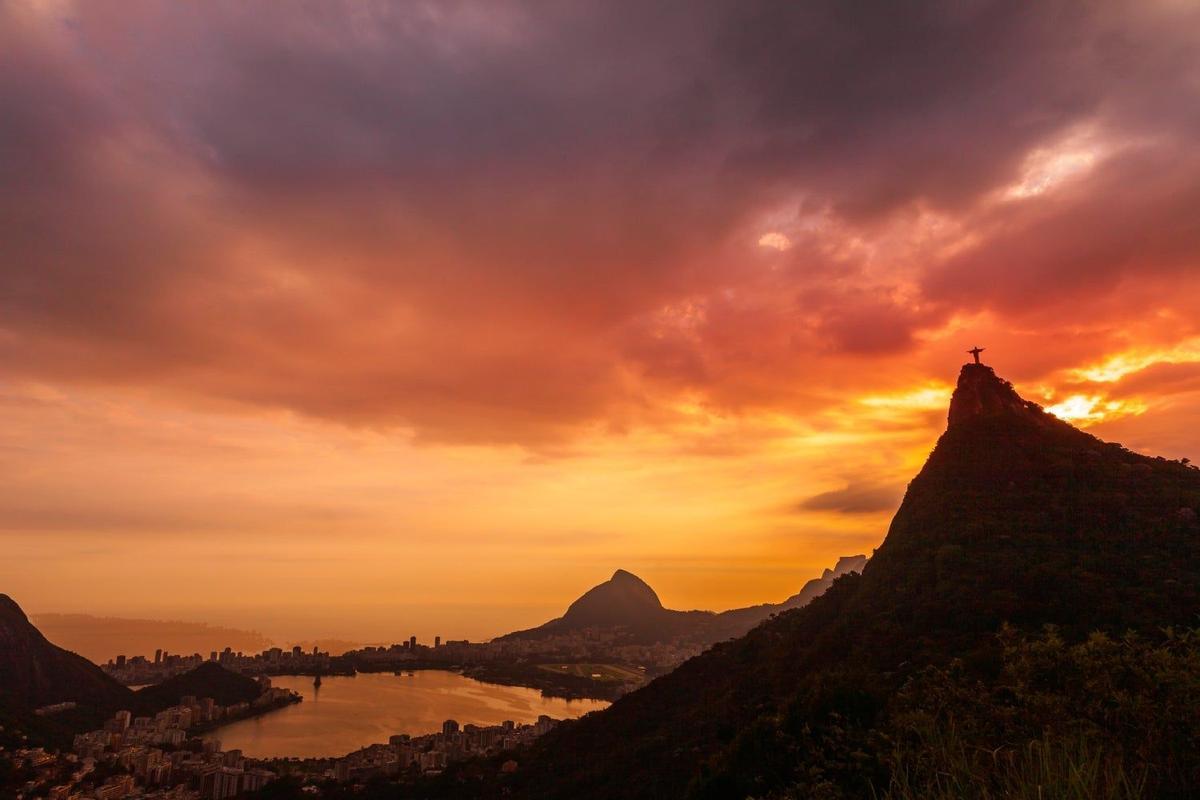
[506,365,1200,799]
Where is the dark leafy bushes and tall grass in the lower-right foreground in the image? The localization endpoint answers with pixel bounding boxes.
[878,630,1200,800]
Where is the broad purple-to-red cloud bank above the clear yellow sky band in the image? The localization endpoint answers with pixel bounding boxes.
[0,1,1200,443]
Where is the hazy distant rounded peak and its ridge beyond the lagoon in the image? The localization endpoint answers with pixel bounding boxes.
[499,555,866,644]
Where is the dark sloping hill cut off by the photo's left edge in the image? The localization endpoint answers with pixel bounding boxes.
[0,595,133,711]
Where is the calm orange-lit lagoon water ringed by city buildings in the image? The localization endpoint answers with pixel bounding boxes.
[211,669,608,758]
